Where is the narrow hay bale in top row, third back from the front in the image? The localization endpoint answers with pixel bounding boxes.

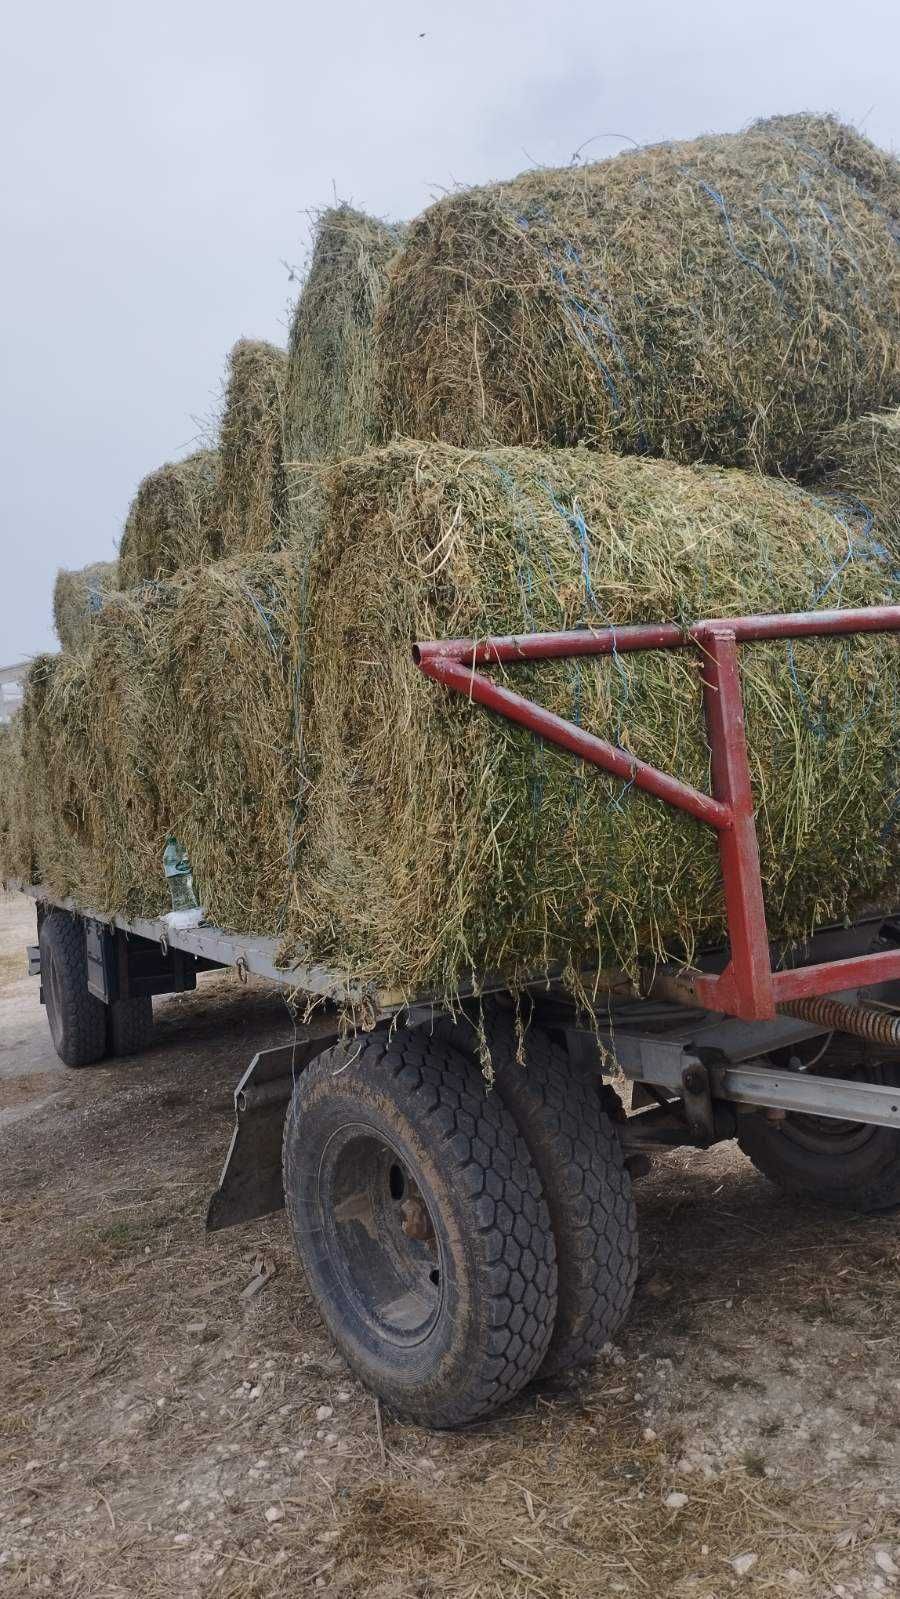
[217,339,288,555]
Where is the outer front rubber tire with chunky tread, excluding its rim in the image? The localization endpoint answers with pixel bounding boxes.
[283,1030,556,1428]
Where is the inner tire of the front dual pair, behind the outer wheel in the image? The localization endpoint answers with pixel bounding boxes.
[440,1006,638,1377]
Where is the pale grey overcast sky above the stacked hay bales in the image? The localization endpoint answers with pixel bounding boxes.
[0,0,900,665]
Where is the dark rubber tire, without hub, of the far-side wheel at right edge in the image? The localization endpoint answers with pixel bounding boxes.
[737,1046,900,1214]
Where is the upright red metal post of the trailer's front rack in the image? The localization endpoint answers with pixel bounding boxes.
[697,627,775,1022]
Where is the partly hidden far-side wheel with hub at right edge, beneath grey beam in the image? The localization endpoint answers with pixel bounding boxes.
[737,1038,900,1210]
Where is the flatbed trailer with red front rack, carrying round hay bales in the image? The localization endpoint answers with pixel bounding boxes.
[12,606,900,1426]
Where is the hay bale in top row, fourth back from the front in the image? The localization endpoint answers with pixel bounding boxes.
[118,449,221,588]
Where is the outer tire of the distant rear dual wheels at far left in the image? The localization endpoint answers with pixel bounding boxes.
[38,910,107,1067]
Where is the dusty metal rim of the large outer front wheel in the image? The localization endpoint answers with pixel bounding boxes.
[317,1124,444,1345]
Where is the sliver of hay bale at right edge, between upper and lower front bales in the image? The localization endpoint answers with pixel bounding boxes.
[822,411,900,560]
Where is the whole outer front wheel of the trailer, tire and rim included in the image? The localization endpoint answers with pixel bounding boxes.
[283,1030,556,1426]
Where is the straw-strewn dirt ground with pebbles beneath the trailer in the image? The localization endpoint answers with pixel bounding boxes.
[0,895,900,1599]
